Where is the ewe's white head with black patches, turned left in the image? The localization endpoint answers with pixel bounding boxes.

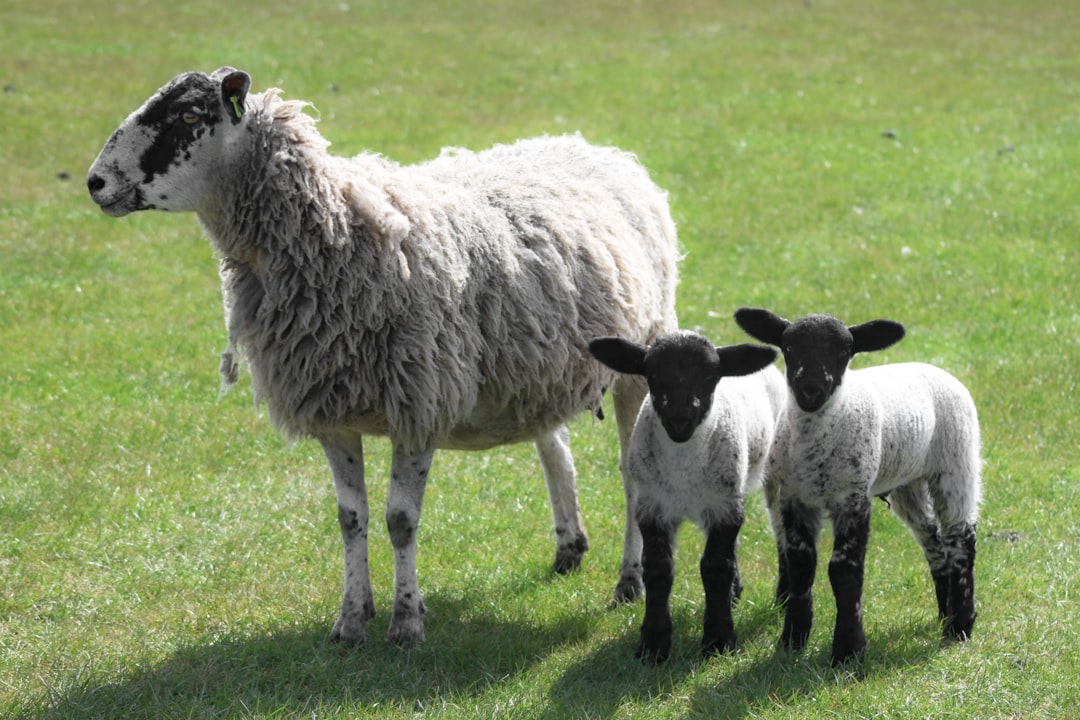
[86,68,251,217]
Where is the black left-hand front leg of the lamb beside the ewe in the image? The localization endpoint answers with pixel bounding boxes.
[634,518,673,663]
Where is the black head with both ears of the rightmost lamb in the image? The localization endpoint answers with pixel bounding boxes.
[735,308,904,412]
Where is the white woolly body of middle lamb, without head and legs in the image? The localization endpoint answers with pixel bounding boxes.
[630,365,785,529]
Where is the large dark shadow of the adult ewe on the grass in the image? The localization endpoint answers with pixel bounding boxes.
[16,594,589,720]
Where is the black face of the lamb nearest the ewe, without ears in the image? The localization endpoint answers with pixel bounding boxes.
[645,334,720,443]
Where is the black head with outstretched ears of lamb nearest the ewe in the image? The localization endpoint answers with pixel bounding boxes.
[589,331,777,443]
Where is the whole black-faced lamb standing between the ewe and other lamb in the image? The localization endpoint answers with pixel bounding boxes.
[589,331,784,662]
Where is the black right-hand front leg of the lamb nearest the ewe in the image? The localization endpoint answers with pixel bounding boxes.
[701,517,742,655]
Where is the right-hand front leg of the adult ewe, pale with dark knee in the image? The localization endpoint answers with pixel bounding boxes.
[387,446,434,644]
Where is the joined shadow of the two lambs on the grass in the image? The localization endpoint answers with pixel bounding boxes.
[543,607,948,720]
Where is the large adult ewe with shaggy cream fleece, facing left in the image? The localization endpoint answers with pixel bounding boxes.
[87,67,677,642]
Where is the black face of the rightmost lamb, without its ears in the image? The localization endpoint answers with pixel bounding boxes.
[780,315,854,412]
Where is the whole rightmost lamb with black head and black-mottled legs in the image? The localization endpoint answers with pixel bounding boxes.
[735,308,982,665]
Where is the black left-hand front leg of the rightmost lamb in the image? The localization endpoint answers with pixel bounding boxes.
[780,500,821,651]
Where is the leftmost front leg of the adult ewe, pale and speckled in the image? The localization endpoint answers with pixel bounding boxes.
[321,435,375,644]
